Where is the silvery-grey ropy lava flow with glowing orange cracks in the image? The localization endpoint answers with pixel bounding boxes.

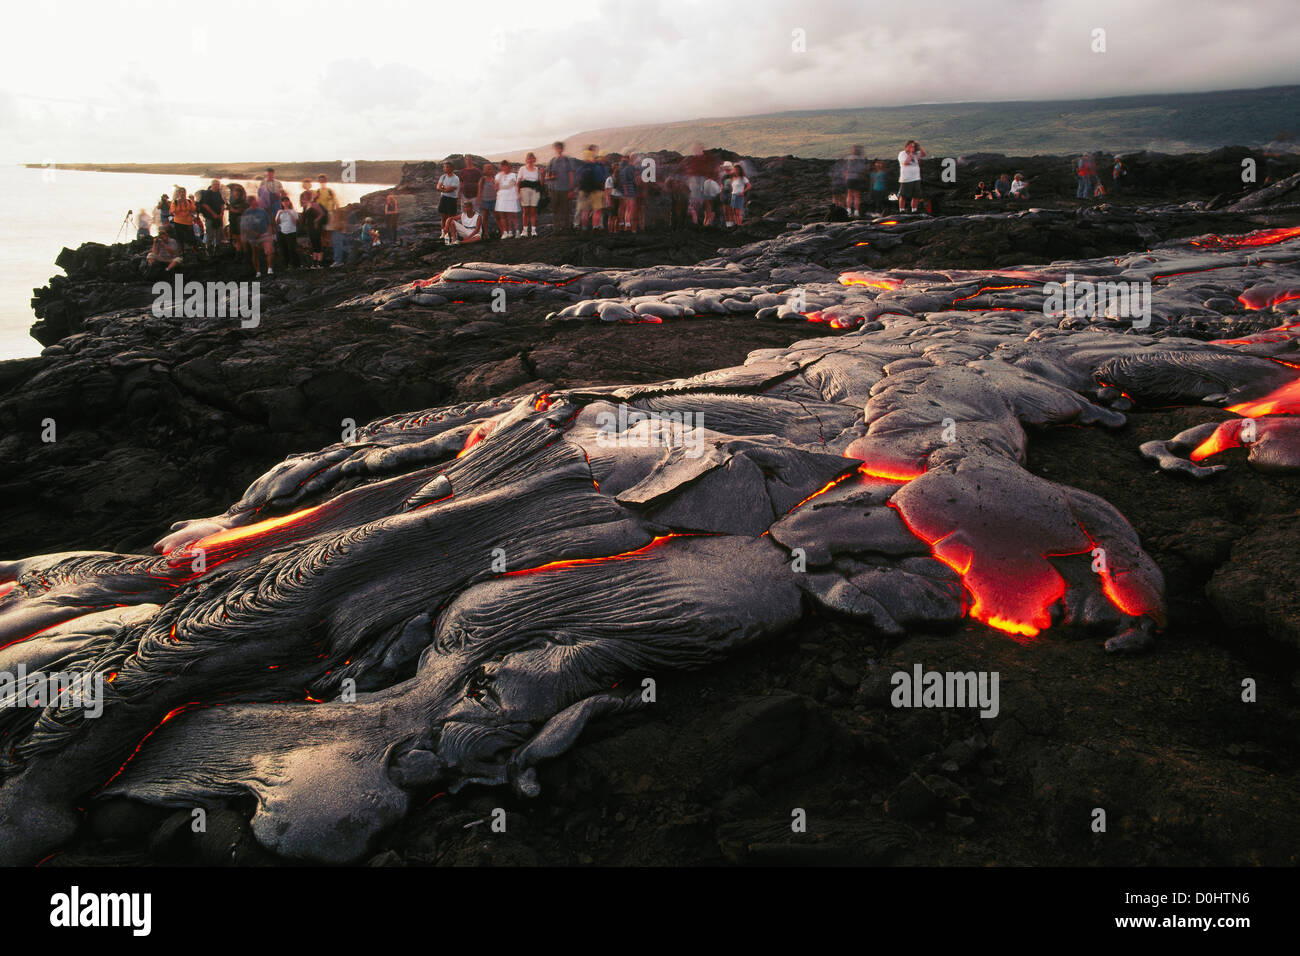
[0,221,1300,864]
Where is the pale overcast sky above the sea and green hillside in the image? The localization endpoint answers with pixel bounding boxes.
[0,0,1300,163]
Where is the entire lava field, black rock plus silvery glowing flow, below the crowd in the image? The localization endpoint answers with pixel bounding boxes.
[0,162,1300,865]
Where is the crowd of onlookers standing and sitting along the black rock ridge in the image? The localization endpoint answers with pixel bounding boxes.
[137,139,1128,277]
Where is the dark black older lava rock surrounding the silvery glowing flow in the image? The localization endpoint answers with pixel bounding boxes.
[0,150,1300,865]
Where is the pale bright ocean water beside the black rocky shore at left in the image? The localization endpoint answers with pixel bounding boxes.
[0,166,385,359]
